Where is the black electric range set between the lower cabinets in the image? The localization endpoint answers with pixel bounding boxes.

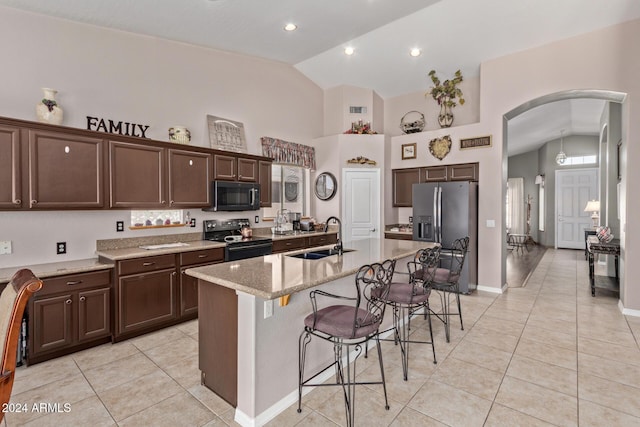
[202,218,273,261]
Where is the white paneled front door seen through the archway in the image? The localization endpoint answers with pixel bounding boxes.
[556,169,598,249]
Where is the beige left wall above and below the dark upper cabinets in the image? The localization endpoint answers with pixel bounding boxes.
[0,7,323,267]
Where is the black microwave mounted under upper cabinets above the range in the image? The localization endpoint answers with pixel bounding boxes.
[203,181,260,211]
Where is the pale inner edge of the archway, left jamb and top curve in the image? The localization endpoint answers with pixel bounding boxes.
[501,90,626,290]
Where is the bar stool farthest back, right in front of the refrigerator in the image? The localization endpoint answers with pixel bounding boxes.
[427,236,469,342]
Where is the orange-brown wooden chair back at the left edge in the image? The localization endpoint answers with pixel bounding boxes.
[0,269,42,421]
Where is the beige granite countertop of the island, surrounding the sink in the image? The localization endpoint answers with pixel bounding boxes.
[185,239,437,299]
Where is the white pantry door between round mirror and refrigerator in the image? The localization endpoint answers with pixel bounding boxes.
[342,169,380,241]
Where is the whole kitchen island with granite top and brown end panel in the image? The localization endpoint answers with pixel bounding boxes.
[186,239,434,426]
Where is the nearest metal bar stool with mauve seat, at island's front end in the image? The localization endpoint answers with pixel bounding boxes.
[298,260,395,427]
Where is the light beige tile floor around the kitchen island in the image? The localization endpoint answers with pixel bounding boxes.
[6,250,640,427]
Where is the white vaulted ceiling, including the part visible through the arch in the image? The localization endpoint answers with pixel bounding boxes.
[0,0,640,152]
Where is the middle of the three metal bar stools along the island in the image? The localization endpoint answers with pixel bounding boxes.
[374,246,440,381]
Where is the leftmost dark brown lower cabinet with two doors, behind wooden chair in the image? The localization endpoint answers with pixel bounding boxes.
[27,270,112,364]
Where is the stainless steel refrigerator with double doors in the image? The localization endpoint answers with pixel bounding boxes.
[412,181,478,294]
